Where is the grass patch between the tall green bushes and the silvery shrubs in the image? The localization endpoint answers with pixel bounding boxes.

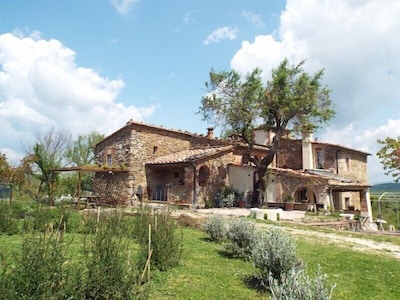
[151,229,268,299]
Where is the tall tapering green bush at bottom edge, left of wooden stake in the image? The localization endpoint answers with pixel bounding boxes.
[82,213,146,299]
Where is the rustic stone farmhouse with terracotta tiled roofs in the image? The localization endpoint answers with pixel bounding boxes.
[94,120,371,216]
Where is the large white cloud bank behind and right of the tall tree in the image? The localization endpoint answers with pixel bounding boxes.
[231,0,400,181]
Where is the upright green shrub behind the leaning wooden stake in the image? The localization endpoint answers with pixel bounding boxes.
[135,208,182,271]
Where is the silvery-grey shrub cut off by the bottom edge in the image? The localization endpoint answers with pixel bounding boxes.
[269,266,335,300]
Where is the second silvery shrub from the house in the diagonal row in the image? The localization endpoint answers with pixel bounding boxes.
[225,218,257,259]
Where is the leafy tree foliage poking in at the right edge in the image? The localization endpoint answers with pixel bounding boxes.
[376,136,400,182]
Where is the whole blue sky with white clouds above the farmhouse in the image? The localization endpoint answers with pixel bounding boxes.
[0,0,400,184]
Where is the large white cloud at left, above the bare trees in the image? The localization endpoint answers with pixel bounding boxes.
[0,33,156,158]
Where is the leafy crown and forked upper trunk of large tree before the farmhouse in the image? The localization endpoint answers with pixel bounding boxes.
[200,59,335,170]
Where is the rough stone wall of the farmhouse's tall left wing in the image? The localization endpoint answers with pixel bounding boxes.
[95,122,230,204]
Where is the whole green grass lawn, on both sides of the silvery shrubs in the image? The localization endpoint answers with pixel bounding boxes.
[0,224,400,300]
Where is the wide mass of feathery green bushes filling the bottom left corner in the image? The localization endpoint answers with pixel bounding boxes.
[0,214,148,300]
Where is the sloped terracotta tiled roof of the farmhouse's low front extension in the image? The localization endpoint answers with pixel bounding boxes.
[146,145,233,165]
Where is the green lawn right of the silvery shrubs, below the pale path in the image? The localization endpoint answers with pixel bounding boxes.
[297,239,400,300]
